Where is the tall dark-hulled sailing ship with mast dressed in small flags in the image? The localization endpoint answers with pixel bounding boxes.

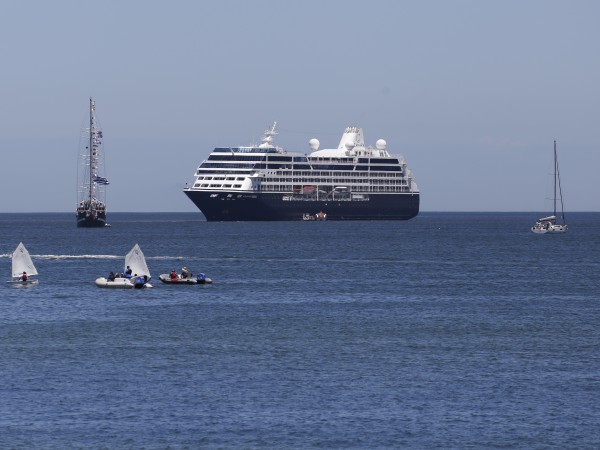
[77,98,109,228]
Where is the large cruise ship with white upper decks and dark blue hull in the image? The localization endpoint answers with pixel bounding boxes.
[184,122,420,221]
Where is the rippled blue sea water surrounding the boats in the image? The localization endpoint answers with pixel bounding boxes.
[0,213,600,449]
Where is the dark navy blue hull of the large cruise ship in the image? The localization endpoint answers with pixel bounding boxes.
[185,191,419,222]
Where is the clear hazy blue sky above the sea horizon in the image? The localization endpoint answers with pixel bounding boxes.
[0,0,600,213]
